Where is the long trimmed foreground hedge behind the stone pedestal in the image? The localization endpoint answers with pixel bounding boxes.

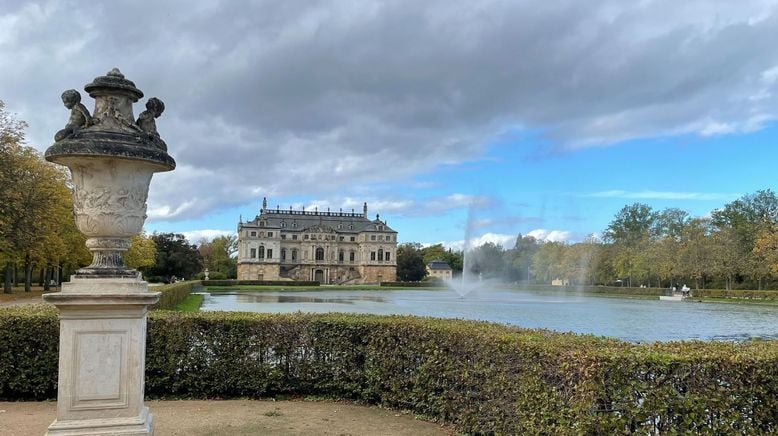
[0,307,778,434]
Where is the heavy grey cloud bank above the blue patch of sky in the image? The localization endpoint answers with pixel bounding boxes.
[0,0,778,219]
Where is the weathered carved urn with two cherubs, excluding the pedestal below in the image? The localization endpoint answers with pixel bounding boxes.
[46,68,175,277]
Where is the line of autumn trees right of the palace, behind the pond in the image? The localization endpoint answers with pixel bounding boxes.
[397,189,778,289]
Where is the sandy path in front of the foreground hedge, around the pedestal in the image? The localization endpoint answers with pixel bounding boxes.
[0,400,454,436]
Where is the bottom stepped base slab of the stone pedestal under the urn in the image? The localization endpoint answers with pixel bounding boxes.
[46,407,154,436]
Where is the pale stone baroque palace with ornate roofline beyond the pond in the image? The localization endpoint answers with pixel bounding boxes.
[238,198,397,284]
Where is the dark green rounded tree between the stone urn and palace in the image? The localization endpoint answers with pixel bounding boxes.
[146,233,203,281]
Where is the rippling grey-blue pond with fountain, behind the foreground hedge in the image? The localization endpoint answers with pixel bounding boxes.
[201,290,778,342]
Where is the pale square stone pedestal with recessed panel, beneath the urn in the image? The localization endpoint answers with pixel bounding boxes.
[44,276,159,435]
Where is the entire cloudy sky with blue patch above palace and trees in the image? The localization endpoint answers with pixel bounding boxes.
[0,0,778,248]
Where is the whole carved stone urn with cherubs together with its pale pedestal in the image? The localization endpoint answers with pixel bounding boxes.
[44,68,175,435]
